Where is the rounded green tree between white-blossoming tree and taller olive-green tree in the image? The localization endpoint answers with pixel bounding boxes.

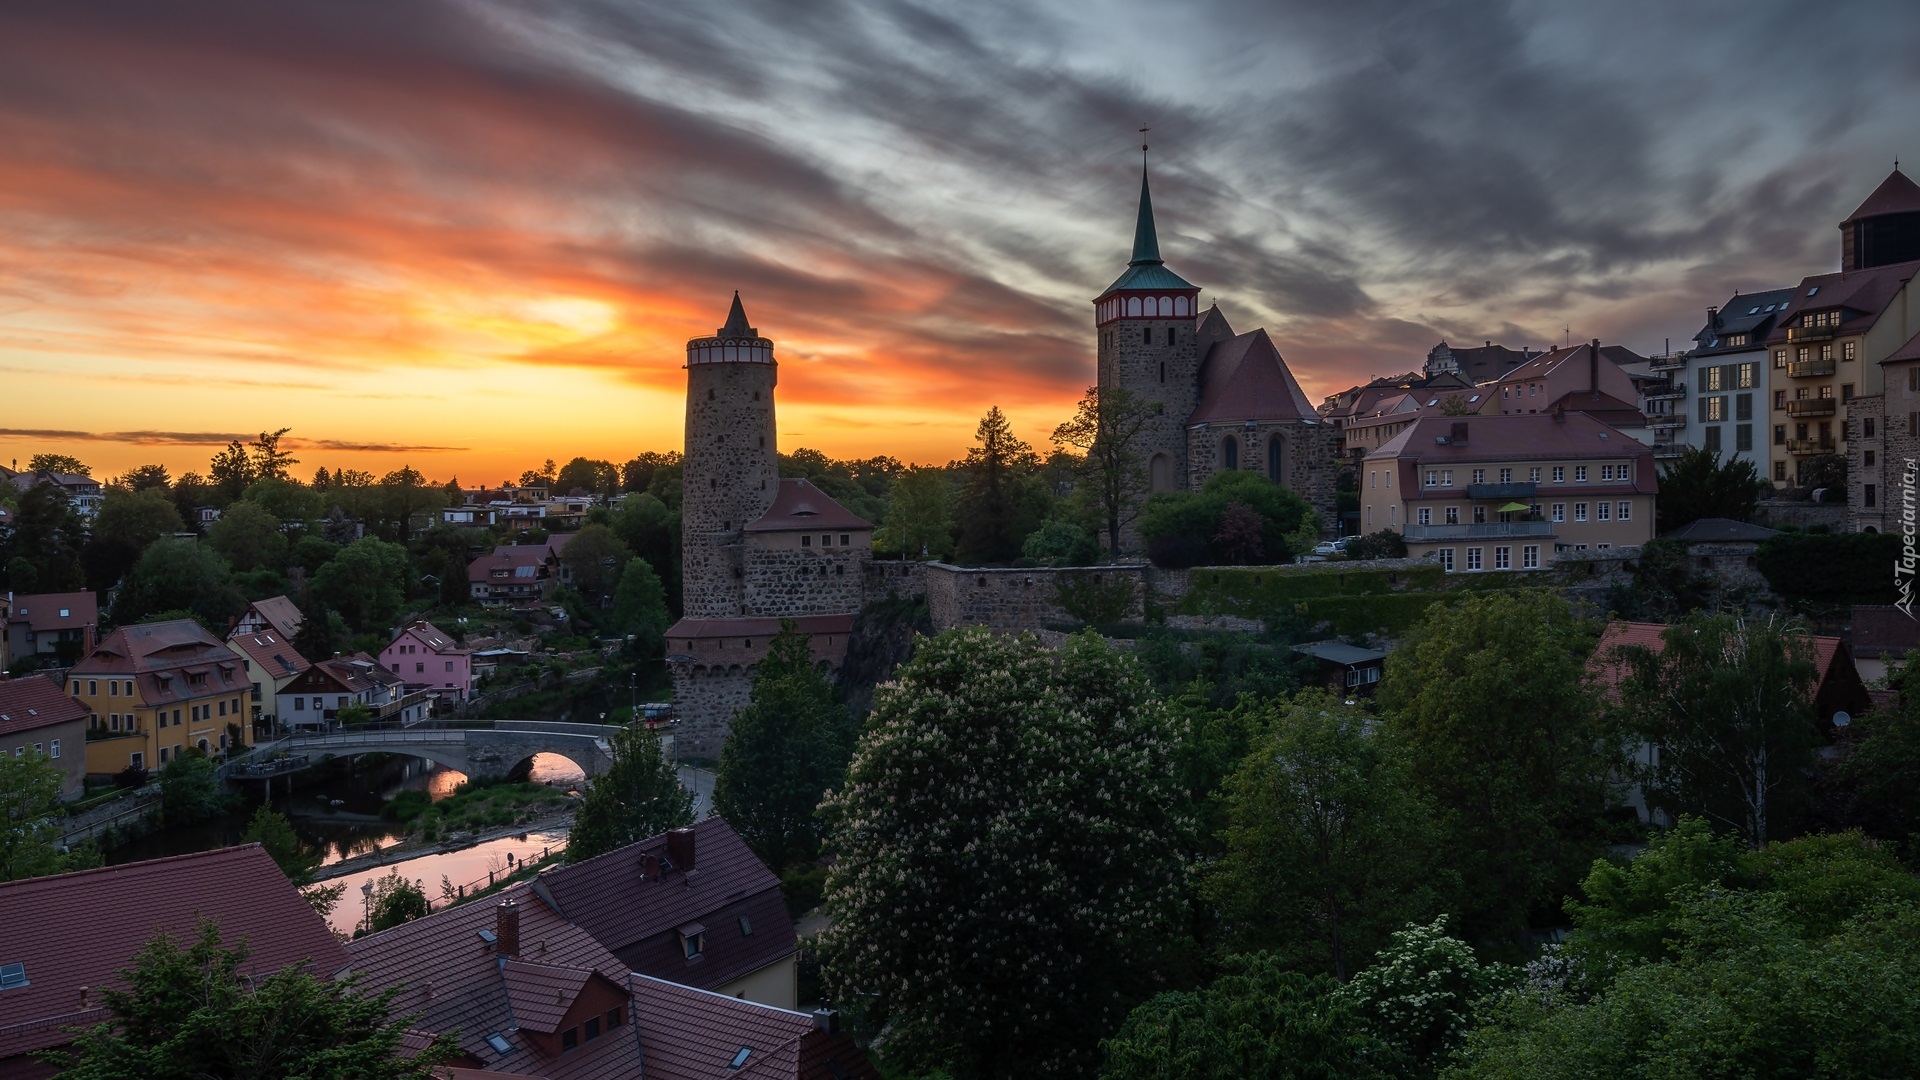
[1206,688,1438,980]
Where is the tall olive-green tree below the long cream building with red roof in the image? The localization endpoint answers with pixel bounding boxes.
[1379,592,1624,936]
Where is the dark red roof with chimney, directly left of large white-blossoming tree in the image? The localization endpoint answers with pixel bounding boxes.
[537,817,795,988]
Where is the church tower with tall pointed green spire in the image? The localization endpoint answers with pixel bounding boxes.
[1092,158,1206,492]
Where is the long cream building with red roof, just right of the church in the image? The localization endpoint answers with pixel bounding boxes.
[1359,411,1657,571]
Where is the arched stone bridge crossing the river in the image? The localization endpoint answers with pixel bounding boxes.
[221,721,618,780]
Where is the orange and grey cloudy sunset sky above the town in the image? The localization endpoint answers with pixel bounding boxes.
[0,0,1920,482]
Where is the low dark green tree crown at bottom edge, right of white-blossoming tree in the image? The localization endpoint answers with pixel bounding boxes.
[1100,955,1386,1080]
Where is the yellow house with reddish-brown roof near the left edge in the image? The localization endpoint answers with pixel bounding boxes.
[67,619,253,774]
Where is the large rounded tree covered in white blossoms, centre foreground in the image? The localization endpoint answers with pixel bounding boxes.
[820,628,1188,1080]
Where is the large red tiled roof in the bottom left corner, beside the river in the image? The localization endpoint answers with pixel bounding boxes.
[0,844,348,1074]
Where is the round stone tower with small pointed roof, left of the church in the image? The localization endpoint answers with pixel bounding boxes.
[680,292,780,619]
